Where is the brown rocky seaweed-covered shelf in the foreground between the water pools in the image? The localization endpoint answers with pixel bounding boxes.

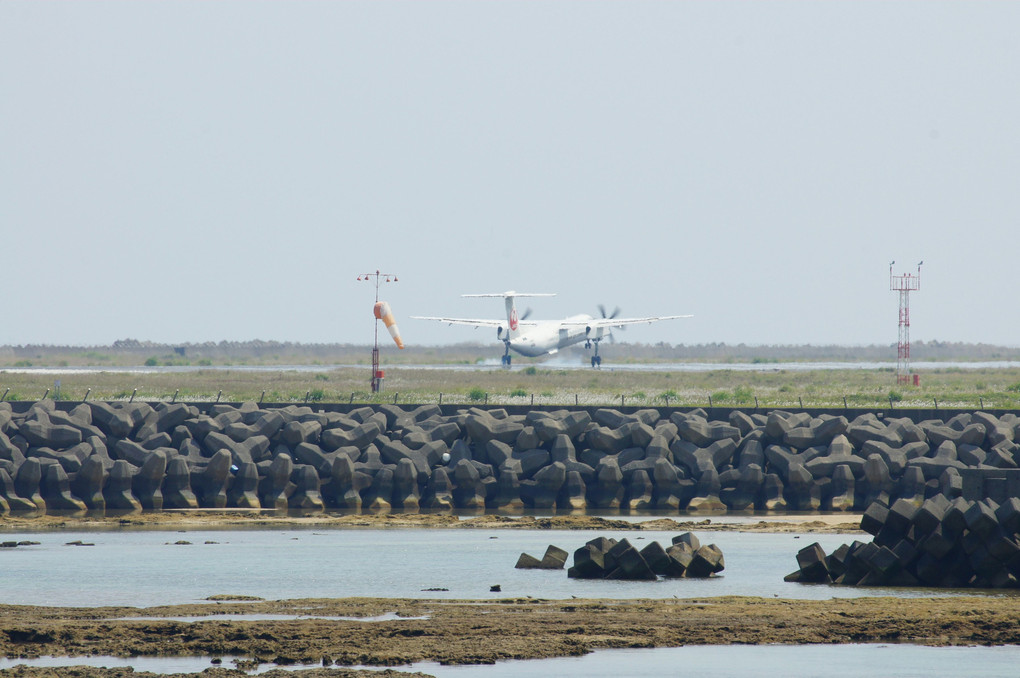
[0,596,1020,675]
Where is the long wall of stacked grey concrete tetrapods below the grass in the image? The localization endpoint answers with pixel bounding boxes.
[0,400,1020,514]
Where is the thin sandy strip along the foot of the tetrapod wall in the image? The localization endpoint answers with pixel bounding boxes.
[0,510,861,535]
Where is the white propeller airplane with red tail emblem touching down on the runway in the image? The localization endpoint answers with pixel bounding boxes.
[411,291,693,367]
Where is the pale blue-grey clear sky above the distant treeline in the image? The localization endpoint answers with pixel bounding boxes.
[0,0,1020,346]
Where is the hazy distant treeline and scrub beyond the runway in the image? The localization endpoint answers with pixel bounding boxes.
[0,340,1020,364]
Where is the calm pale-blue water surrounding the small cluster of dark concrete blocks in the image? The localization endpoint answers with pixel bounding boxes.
[0,527,1007,607]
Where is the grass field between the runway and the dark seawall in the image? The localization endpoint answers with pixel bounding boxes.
[0,358,1020,409]
